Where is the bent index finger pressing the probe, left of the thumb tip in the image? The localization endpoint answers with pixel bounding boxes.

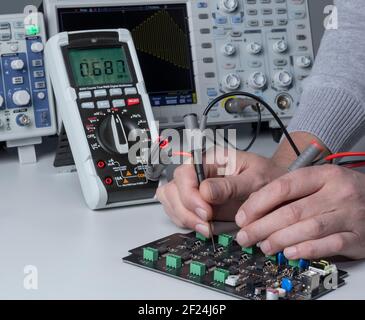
[170,164,213,221]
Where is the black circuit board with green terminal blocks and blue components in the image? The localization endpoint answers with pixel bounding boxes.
[123,232,348,300]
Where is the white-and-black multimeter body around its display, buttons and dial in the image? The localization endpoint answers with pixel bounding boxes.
[45,29,159,209]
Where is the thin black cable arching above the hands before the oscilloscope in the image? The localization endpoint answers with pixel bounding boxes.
[203,91,300,156]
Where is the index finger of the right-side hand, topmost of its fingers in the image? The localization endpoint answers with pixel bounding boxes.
[237,168,326,227]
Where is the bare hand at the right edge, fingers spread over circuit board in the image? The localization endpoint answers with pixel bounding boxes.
[236,165,365,259]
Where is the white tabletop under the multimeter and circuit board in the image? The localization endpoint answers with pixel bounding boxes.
[0,133,365,299]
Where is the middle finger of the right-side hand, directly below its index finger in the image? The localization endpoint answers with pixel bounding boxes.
[236,192,330,246]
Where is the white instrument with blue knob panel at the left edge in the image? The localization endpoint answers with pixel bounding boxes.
[0,6,56,163]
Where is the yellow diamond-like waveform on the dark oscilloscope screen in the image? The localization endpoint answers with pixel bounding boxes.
[131,10,190,69]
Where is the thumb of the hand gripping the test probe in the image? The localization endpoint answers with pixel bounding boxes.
[200,172,262,204]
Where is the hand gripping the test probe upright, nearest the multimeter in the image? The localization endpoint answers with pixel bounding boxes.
[157,151,287,236]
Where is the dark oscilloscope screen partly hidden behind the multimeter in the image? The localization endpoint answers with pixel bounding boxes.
[58,4,197,107]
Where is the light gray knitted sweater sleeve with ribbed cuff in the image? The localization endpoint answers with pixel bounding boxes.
[289,0,365,152]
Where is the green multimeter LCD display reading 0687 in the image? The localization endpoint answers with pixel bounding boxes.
[69,47,133,87]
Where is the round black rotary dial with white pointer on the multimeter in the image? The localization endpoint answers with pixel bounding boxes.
[96,115,129,154]
